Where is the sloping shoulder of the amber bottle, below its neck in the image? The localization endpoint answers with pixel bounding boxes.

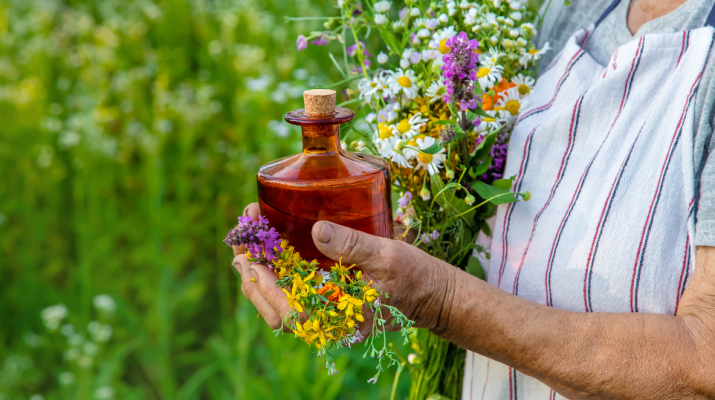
[258,152,389,184]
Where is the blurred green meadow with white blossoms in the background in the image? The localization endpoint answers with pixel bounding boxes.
[0,0,409,400]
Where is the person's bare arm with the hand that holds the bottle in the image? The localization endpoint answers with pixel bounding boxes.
[231,205,715,399]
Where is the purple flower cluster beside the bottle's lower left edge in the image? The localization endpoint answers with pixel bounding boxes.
[223,215,283,264]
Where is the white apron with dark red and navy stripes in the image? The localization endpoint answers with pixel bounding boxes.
[463,0,715,400]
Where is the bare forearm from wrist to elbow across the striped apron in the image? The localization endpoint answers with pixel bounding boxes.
[433,269,709,399]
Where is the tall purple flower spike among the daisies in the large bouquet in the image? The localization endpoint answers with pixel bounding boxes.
[442,32,479,110]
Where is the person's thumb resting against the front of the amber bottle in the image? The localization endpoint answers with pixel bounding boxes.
[311,221,393,266]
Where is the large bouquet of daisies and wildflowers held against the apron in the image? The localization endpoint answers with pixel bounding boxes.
[288,0,549,399]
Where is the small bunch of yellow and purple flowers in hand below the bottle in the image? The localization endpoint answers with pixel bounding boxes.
[224,216,412,383]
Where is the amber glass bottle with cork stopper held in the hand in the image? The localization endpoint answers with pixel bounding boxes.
[258,89,392,269]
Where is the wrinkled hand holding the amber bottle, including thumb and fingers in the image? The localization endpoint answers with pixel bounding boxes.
[233,203,457,334]
